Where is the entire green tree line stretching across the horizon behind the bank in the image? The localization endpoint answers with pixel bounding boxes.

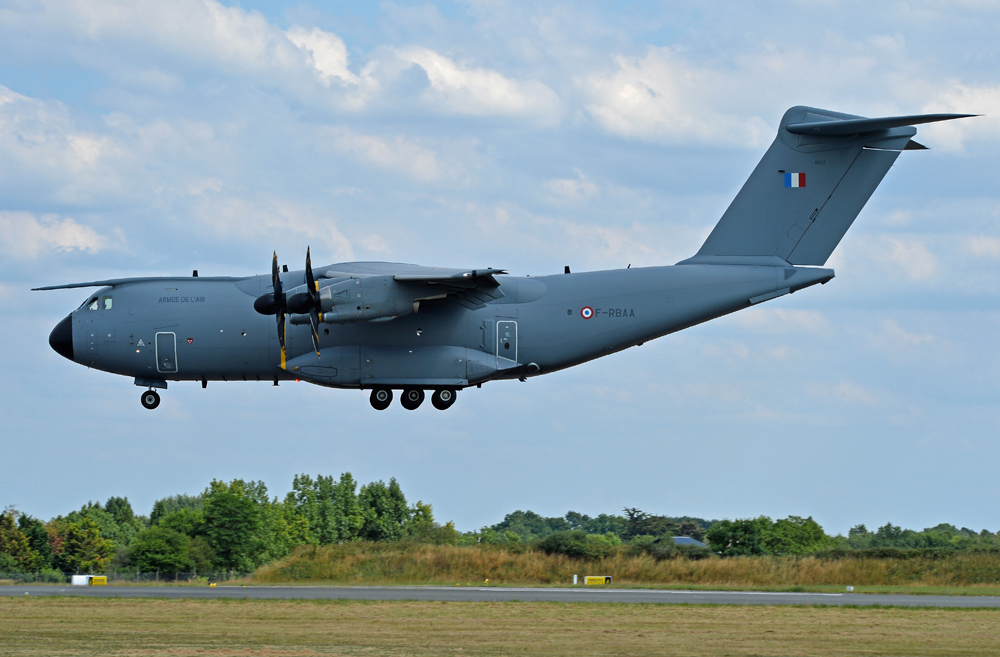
[0,473,1000,581]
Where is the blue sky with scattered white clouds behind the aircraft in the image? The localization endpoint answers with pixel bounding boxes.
[0,0,1000,534]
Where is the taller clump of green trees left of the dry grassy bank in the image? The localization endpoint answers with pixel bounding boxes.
[0,473,458,581]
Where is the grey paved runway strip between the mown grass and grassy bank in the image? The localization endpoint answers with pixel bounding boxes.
[0,585,1000,608]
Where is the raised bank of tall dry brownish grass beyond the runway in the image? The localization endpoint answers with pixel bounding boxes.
[253,543,1000,595]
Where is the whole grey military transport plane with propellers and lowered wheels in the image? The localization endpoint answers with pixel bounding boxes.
[37,107,973,410]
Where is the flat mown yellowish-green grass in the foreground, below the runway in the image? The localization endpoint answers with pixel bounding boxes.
[0,598,1000,657]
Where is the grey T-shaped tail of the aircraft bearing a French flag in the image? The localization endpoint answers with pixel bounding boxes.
[679,107,975,266]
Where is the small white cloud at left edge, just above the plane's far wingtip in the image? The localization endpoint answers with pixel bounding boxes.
[0,212,114,260]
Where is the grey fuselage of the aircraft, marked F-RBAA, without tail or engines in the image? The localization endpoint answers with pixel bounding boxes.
[60,263,833,388]
